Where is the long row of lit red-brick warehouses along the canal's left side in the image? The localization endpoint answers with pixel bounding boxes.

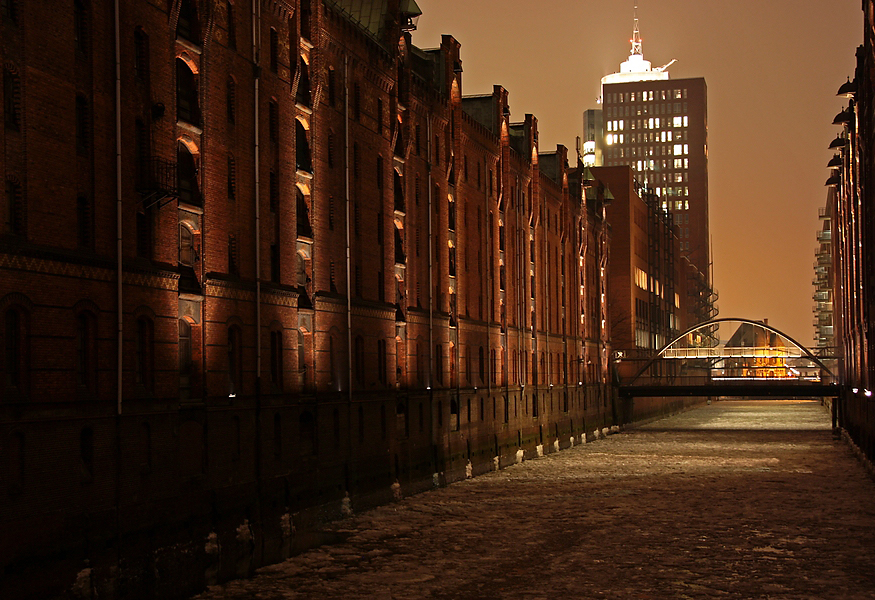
[0,0,700,597]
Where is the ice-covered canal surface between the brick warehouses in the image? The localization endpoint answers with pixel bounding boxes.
[198,401,875,599]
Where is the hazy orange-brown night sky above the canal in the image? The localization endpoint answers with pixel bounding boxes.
[413,0,863,345]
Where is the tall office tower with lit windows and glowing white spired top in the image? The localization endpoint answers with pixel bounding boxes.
[583,12,716,338]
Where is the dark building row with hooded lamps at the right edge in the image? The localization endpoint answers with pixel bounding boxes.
[828,0,875,460]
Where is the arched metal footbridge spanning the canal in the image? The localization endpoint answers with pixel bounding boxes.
[614,318,840,397]
